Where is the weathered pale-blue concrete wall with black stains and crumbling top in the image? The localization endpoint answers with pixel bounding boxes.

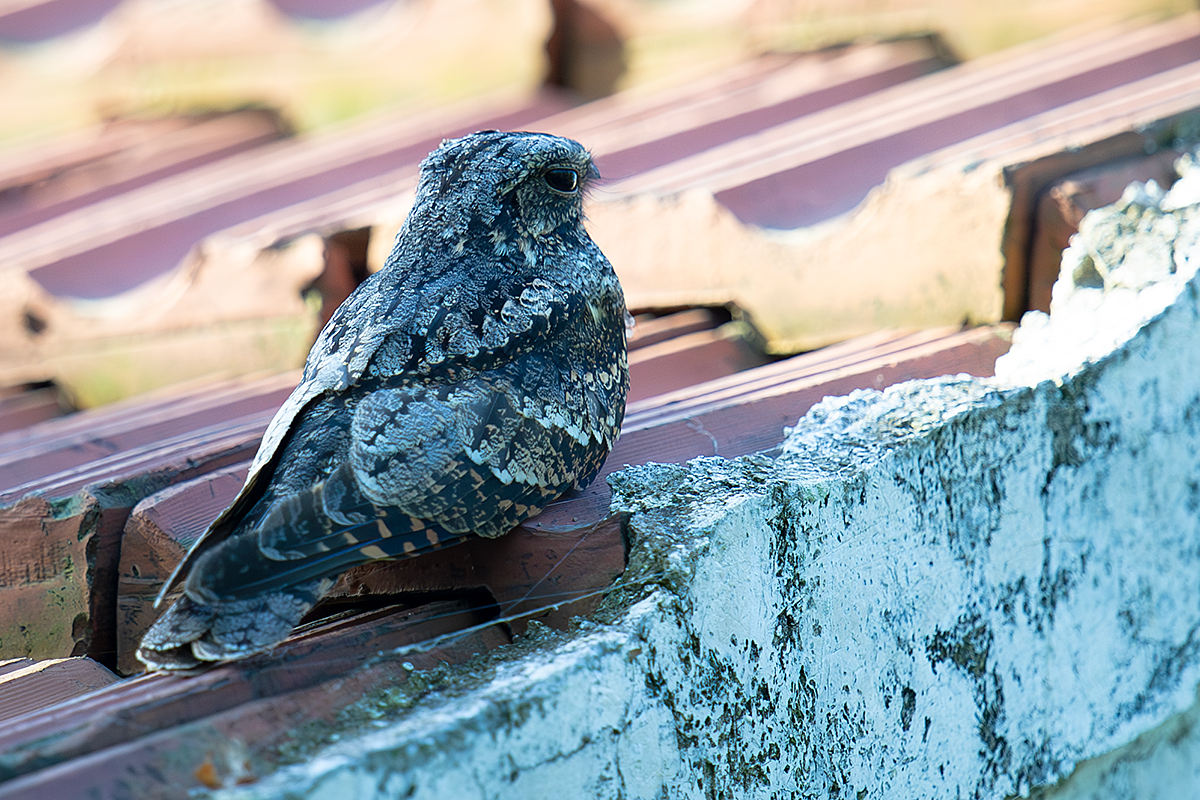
[211,164,1200,800]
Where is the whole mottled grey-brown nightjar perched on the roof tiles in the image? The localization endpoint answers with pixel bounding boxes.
[137,131,631,670]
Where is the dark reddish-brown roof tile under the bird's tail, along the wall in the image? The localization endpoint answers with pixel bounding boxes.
[0,601,509,798]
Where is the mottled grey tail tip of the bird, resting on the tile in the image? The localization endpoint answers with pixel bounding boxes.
[138,579,332,670]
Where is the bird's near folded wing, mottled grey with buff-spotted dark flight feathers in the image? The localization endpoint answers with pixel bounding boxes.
[188,378,607,602]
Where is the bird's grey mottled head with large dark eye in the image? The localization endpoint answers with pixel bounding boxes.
[413,131,600,243]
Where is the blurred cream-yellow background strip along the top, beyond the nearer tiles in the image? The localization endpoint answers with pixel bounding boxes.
[0,0,1195,145]
